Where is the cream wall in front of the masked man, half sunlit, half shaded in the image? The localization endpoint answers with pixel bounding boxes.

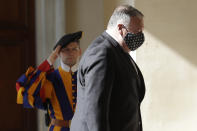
[135,0,197,131]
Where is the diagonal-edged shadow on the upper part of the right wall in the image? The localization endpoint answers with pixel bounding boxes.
[135,0,197,66]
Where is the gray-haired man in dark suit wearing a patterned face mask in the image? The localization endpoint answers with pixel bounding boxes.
[71,5,145,131]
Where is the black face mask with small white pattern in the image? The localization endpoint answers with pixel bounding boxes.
[124,32,144,51]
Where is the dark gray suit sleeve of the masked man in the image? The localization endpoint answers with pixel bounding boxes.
[84,48,114,131]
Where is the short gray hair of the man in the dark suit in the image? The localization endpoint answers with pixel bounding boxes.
[107,5,144,28]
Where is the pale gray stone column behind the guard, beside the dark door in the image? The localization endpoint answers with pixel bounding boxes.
[36,0,65,131]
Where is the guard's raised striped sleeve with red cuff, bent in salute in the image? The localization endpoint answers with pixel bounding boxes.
[16,60,54,109]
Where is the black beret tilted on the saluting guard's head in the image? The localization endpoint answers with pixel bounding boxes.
[53,31,82,50]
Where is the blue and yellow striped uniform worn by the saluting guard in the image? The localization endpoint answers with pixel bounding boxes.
[16,61,77,131]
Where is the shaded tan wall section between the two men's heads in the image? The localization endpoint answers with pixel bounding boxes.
[66,0,104,50]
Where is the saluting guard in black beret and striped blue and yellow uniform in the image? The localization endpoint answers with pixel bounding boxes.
[16,31,82,131]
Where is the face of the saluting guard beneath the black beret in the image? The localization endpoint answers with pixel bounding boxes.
[60,42,81,67]
